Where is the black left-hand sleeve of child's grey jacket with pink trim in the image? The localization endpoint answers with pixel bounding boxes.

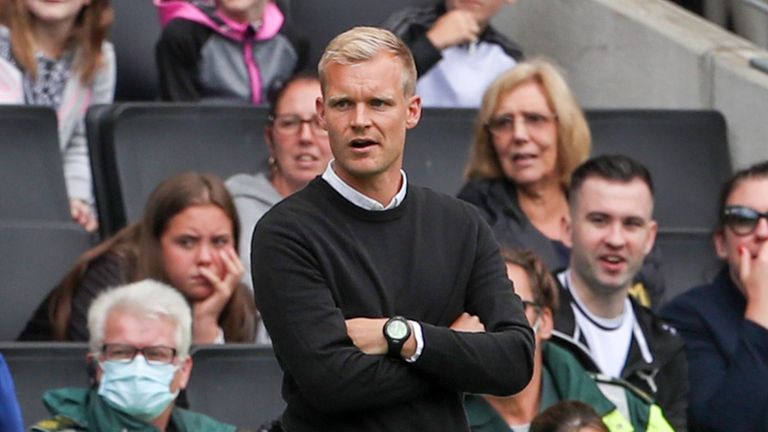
[155,19,205,102]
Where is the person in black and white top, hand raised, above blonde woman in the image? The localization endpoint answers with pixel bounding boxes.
[383,0,523,108]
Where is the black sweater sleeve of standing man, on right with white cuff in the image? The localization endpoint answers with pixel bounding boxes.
[404,220,534,396]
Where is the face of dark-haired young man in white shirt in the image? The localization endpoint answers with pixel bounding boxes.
[568,177,657,295]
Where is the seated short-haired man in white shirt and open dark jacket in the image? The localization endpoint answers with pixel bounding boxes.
[552,155,688,431]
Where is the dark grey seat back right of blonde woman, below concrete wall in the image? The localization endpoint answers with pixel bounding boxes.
[586,110,731,230]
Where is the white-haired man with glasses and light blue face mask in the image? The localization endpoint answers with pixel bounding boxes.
[32,279,235,432]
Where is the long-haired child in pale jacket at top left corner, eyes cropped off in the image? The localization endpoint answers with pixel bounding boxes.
[0,0,115,232]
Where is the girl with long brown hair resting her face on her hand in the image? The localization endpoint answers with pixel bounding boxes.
[20,172,256,343]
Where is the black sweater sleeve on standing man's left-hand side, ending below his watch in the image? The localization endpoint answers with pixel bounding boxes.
[251,214,432,414]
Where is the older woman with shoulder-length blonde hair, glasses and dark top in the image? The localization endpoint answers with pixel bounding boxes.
[458,59,664,306]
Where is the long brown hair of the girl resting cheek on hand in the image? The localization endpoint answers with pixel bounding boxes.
[48,172,255,342]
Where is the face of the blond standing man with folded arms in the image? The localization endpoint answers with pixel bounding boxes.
[317,52,421,187]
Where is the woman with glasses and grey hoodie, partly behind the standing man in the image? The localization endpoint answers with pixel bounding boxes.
[227,74,331,296]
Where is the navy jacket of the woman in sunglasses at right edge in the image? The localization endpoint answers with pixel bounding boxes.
[662,298,768,432]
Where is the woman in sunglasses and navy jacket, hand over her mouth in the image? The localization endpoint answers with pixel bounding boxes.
[662,162,768,432]
